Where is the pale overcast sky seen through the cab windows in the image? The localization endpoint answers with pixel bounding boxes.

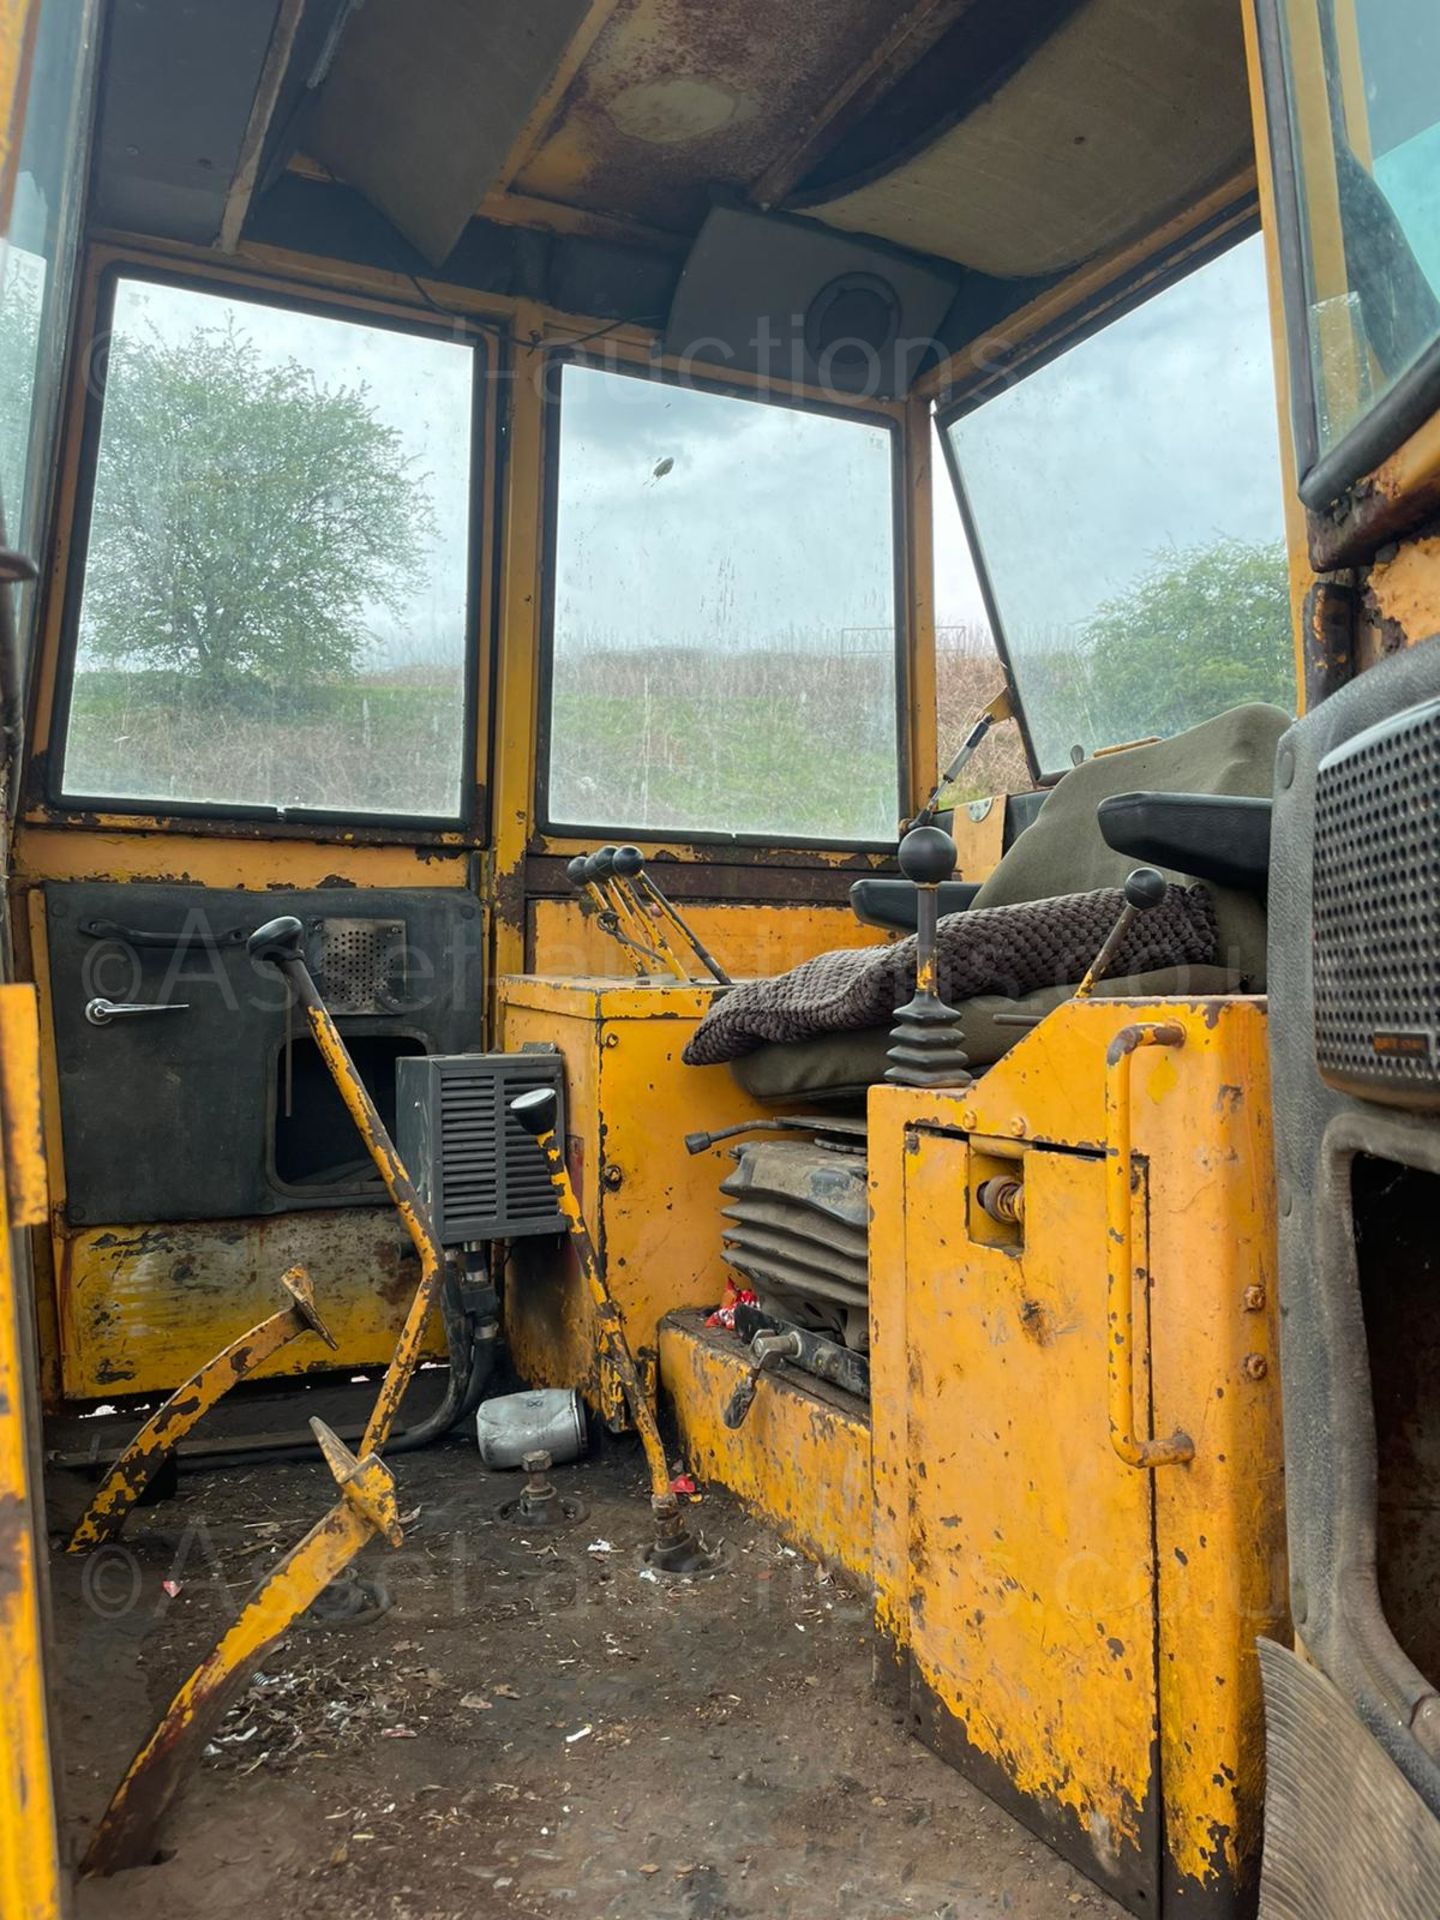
[101,240,1283,725]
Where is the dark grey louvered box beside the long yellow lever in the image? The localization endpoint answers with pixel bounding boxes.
[396,1054,564,1246]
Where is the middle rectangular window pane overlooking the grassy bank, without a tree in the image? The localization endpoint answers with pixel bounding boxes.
[549,367,899,841]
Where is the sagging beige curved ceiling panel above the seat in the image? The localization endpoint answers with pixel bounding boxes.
[794,0,1252,276]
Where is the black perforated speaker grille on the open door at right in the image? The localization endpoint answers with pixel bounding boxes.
[1313,701,1440,1106]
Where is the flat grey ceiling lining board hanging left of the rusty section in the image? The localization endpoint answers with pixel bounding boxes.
[300,0,589,265]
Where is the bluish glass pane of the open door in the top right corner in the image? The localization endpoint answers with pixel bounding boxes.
[1286,0,1440,449]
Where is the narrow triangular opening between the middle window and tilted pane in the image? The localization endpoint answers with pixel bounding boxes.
[933,434,1035,801]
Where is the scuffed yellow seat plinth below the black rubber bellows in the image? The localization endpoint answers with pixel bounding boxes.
[660,1313,872,1590]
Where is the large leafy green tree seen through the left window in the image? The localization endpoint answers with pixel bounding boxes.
[83,326,432,693]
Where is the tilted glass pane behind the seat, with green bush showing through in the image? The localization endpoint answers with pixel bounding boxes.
[948,236,1294,772]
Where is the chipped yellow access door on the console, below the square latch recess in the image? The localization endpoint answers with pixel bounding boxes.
[891,1131,1156,1885]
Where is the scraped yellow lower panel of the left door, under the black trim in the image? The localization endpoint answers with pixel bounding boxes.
[56,1208,444,1400]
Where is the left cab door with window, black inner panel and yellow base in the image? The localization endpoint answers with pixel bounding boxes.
[21,253,493,1400]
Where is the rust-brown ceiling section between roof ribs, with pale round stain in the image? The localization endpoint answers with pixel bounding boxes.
[513,0,897,232]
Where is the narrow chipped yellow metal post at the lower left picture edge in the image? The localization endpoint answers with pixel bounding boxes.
[0,987,61,1920]
